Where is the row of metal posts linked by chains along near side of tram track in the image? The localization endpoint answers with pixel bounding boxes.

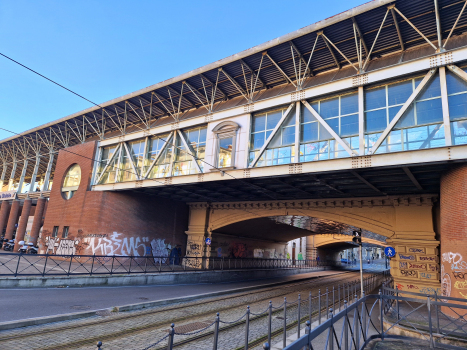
[93,271,389,350]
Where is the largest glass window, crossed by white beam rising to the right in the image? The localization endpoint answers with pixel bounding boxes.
[365,75,445,154]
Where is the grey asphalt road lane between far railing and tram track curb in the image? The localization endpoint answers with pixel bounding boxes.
[0,271,341,322]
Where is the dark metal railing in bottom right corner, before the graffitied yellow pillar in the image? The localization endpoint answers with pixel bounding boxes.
[284,283,467,350]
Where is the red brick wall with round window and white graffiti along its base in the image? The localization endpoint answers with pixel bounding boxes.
[39,142,188,255]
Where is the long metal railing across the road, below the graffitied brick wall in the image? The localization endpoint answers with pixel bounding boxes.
[0,253,330,277]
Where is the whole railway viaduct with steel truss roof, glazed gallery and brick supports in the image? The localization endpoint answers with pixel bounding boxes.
[0,0,467,297]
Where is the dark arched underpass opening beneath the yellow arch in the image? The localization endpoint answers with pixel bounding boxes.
[209,215,386,261]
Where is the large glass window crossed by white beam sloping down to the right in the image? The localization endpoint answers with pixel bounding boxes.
[300,93,359,162]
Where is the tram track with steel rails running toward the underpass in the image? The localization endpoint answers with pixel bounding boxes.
[0,271,384,349]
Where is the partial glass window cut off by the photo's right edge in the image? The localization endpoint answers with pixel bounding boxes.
[446,67,467,145]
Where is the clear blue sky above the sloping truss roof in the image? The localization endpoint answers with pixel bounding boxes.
[0,0,364,139]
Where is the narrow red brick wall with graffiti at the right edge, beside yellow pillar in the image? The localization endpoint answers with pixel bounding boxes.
[440,165,467,299]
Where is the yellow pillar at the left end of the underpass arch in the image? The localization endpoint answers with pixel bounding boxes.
[185,203,212,268]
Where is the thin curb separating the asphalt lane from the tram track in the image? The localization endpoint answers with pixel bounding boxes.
[0,270,351,331]
